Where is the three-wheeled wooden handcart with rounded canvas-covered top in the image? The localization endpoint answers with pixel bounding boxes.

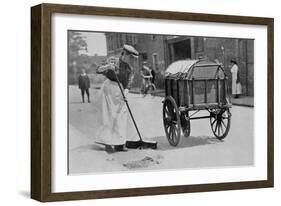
[163,60,232,146]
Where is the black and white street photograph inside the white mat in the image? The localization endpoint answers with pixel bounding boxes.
[67,30,255,175]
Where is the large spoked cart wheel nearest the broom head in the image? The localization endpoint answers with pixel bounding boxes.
[163,96,181,146]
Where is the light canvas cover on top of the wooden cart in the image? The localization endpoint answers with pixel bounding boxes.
[165,60,224,79]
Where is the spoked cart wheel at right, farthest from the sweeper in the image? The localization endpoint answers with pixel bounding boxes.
[210,108,231,140]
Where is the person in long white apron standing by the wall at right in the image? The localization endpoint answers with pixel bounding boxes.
[230,59,242,98]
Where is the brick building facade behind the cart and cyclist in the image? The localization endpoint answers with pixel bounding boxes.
[105,33,254,96]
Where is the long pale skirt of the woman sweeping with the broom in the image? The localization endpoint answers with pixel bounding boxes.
[96,79,138,145]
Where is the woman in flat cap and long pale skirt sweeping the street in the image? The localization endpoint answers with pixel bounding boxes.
[96,45,139,152]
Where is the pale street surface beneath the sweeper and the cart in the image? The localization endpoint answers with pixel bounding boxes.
[69,86,254,174]
